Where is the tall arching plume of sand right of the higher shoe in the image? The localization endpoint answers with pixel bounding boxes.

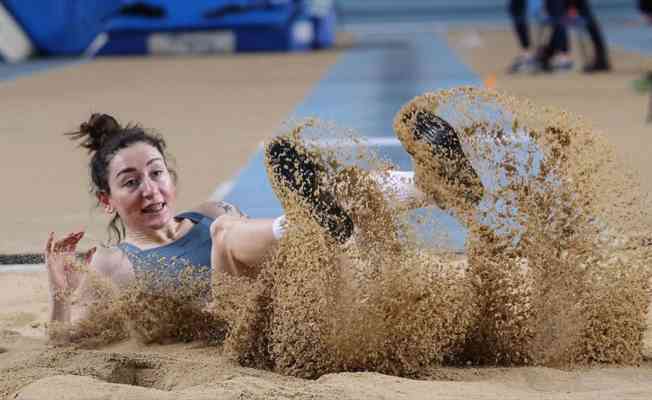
[397,88,650,366]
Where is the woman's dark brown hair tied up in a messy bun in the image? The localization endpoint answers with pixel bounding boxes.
[65,114,177,243]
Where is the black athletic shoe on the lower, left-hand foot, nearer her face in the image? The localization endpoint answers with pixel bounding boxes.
[265,137,353,243]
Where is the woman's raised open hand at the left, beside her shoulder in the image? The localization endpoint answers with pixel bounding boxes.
[45,232,96,302]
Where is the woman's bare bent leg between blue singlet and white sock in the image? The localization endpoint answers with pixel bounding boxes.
[211,215,278,277]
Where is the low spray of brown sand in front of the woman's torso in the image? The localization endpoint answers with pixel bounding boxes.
[48,266,225,348]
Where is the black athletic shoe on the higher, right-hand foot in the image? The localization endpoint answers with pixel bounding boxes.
[403,110,482,203]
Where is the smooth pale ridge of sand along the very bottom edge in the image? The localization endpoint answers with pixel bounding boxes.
[15,360,652,400]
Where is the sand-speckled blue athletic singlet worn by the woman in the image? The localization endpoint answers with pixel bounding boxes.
[118,211,213,282]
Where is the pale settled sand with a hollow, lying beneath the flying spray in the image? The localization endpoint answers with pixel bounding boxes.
[0,345,652,400]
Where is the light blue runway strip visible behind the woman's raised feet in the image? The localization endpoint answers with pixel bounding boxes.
[220,26,479,247]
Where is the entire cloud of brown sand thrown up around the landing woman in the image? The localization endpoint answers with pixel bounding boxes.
[40,88,650,378]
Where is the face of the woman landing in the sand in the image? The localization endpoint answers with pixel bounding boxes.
[100,142,176,231]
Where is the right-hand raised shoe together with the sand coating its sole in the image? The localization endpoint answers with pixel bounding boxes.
[394,98,483,204]
